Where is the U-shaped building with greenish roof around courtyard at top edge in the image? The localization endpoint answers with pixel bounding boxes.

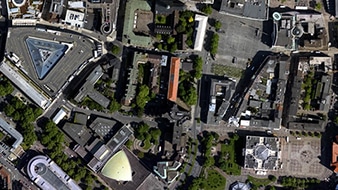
[122,0,153,47]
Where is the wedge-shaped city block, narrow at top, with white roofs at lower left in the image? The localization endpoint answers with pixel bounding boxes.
[240,55,290,130]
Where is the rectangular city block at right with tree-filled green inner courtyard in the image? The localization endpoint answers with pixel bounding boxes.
[282,53,332,131]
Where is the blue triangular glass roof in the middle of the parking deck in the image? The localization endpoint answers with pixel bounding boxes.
[26,37,68,79]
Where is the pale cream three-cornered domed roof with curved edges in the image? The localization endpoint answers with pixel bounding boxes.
[101,150,132,181]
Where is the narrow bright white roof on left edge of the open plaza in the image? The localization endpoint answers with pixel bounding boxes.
[194,14,208,51]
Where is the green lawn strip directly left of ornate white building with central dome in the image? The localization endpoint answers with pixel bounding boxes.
[220,139,241,175]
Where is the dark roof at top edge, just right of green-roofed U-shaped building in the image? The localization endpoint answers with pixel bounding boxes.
[155,0,186,14]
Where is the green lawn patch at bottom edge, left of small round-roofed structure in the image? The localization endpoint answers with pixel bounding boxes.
[205,170,226,190]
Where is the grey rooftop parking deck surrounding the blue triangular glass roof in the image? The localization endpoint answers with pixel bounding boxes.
[6,27,95,96]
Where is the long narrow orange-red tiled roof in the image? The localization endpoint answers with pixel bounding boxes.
[168,57,181,102]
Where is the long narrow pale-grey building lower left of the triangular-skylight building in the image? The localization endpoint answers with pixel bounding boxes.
[0,62,51,109]
